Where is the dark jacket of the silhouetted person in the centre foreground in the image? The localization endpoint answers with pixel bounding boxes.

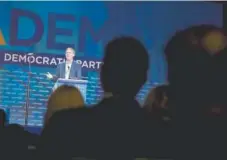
[38,95,151,159]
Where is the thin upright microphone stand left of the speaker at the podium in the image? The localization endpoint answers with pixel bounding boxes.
[25,53,33,126]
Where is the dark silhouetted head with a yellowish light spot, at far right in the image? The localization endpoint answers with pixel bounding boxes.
[165,25,226,90]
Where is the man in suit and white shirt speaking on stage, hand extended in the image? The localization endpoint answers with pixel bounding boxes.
[46,48,81,81]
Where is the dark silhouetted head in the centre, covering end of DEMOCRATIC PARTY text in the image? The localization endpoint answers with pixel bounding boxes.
[101,37,149,97]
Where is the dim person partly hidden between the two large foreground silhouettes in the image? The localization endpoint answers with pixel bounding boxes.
[144,85,173,158]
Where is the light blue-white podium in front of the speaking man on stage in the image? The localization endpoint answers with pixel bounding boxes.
[52,78,87,102]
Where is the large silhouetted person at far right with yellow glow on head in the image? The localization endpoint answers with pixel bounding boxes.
[165,25,227,159]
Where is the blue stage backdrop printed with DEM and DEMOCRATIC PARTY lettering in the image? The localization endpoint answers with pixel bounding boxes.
[0,2,222,126]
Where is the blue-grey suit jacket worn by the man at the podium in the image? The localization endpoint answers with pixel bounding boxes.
[54,61,81,80]
